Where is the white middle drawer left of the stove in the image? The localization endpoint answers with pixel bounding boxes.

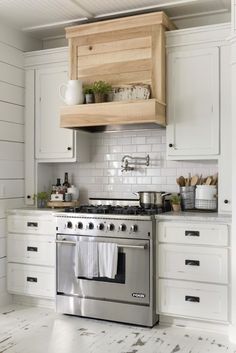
[7,234,56,266]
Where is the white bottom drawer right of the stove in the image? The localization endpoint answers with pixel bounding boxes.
[157,279,228,321]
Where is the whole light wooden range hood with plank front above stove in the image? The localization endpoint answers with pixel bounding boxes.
[61,12,175,131]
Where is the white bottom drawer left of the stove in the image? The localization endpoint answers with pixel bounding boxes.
[7,263,56,298]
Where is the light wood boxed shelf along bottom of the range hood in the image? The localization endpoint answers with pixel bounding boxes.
[61,99,165,128]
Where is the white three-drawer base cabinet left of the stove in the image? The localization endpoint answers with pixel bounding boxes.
[7,210,56,299]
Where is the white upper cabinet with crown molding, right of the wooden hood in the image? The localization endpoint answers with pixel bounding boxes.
[167,25,229,160]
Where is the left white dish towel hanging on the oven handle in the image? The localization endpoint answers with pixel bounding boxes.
[75,241,99,278]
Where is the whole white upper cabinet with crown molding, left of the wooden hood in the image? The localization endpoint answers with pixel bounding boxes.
[25,48,90,205]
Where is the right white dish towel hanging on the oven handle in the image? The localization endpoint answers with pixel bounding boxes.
[98,243,118,279]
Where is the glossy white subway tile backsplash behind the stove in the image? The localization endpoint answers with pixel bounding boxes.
[54,129,218,202]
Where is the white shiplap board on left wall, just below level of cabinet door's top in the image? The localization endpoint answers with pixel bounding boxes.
[0,62,25,87]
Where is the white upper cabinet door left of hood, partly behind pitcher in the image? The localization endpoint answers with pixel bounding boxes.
[35,67,75,161]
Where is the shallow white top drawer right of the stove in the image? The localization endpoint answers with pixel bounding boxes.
[157,222,228,246]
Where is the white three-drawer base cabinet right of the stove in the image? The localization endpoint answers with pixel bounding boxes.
[156,220,229,321]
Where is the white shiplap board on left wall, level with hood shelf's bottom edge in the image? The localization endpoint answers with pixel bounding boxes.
[0,121,24,142]
